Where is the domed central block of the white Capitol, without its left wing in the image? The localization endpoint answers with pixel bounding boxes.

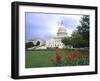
[46,21,67,48]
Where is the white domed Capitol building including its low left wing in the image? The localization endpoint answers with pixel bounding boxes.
[29,21,72,49]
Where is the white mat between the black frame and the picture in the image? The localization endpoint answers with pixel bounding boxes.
[19,6,95,76]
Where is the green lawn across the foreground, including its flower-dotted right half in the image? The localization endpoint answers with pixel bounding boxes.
[25,50,89,68]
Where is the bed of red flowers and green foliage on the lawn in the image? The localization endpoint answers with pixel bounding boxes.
[50,49,89,66]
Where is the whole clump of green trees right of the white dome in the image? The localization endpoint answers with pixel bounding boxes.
[62,15,89,48]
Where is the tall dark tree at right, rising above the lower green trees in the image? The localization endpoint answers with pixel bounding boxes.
[77,15,90,47]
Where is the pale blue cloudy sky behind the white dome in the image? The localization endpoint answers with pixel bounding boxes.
[25,12,82,41]
